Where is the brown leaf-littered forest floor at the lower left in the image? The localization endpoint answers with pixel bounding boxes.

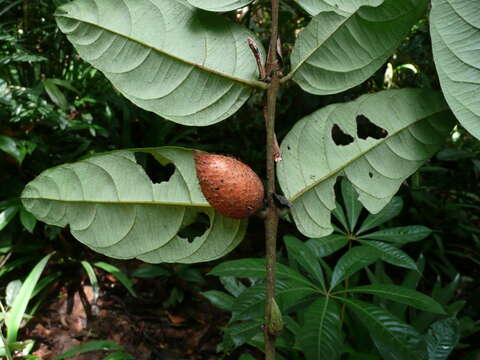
[23,277,255,360]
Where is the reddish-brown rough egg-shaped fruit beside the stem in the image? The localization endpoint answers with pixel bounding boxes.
[193,151,264,219]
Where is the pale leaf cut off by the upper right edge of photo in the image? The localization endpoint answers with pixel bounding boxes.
[430,0,480,139]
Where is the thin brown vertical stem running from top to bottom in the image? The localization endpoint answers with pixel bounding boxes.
[264,0,280,360]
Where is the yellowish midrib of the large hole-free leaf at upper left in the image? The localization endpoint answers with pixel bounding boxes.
[54,11,269,90]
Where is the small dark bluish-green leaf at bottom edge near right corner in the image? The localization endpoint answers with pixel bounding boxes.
[426,318,460,360]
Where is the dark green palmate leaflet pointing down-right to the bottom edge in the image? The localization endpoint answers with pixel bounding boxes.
[338,298,426,360]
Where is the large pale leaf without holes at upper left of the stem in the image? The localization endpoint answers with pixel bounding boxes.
[55,0,266,126]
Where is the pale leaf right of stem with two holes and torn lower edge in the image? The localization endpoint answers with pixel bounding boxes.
[278,89,453,237]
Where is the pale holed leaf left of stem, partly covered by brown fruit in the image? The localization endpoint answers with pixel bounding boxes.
[22,147,247,263]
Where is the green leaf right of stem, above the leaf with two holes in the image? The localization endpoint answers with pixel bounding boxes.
[286,0,426,95]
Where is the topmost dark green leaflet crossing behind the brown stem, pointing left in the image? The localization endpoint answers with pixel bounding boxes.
[209,259,316,289]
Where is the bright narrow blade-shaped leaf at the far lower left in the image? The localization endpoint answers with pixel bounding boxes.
[5,255,51,343]
